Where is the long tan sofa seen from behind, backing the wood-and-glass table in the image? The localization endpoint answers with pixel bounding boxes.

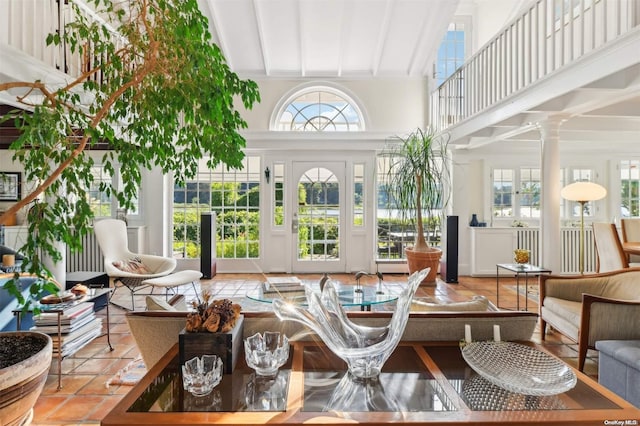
[125,295,538,368]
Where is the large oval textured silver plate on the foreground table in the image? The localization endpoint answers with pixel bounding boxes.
[462,341,577,395]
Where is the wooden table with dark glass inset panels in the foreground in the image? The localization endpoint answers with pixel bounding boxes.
[101,341,640,426]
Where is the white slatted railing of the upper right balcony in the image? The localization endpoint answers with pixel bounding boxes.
[431,0,640,130]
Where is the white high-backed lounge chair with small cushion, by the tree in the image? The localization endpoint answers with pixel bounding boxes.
[93,219,176,309]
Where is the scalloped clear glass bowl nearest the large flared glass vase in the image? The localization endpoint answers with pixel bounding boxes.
[244,331,289,376]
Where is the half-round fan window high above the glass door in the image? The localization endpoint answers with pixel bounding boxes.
[273,86,364,132]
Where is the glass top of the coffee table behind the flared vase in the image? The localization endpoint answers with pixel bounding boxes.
[247,282,398,307]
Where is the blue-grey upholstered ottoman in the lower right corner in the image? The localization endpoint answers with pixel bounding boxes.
[596,340,640,407]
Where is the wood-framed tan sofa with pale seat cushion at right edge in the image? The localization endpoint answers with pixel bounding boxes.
[539,268,640,371]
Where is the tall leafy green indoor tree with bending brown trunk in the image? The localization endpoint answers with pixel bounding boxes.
[0,0,260,306]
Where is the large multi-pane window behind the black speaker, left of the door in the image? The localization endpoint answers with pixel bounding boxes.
[173,156,262,259]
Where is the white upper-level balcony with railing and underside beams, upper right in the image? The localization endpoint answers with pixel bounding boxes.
[430,0,640,149]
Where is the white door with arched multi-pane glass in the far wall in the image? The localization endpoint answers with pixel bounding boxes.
[287,161,346,273]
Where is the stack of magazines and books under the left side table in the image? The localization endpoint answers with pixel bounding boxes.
[31,302,102,357]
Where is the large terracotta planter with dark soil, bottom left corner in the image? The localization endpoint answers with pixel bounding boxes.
[0,331,53,426]
